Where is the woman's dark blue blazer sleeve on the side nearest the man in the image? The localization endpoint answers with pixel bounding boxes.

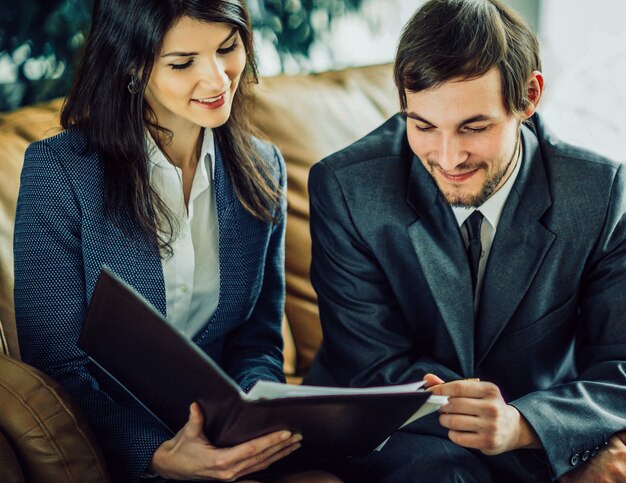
[224,147,287,391]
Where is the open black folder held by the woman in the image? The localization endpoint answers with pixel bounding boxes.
[78,268,429,456]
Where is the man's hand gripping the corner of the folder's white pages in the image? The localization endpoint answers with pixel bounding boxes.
[424,374,541,455]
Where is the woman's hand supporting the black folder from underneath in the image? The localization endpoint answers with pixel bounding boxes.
[149,403,302,481]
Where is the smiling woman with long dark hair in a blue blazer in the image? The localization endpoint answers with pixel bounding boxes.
[15,0,338,481]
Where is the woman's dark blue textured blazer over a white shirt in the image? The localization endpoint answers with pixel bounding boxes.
[14,130,286,480]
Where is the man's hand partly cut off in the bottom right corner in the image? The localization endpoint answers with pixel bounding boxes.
[559,431,626,483]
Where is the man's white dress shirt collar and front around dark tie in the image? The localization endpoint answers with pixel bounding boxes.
[452,144,522,308]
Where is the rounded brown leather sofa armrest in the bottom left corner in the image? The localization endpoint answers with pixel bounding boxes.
[0,354,110,483]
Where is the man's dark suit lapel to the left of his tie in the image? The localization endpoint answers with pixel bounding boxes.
[407,157,474,377]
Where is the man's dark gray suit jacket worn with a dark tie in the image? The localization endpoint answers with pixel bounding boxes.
[308,115,626,477]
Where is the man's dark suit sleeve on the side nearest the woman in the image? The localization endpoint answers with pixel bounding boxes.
[307,162,460,387]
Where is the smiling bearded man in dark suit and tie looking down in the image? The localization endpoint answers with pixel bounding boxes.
[309,0,626,483]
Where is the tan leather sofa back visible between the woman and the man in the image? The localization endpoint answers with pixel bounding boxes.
[252,65,399,376]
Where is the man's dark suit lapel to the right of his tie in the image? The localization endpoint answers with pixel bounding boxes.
[476,127,555,365]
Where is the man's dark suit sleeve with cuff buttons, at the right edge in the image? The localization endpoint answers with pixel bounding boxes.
[511,166,626,477]
